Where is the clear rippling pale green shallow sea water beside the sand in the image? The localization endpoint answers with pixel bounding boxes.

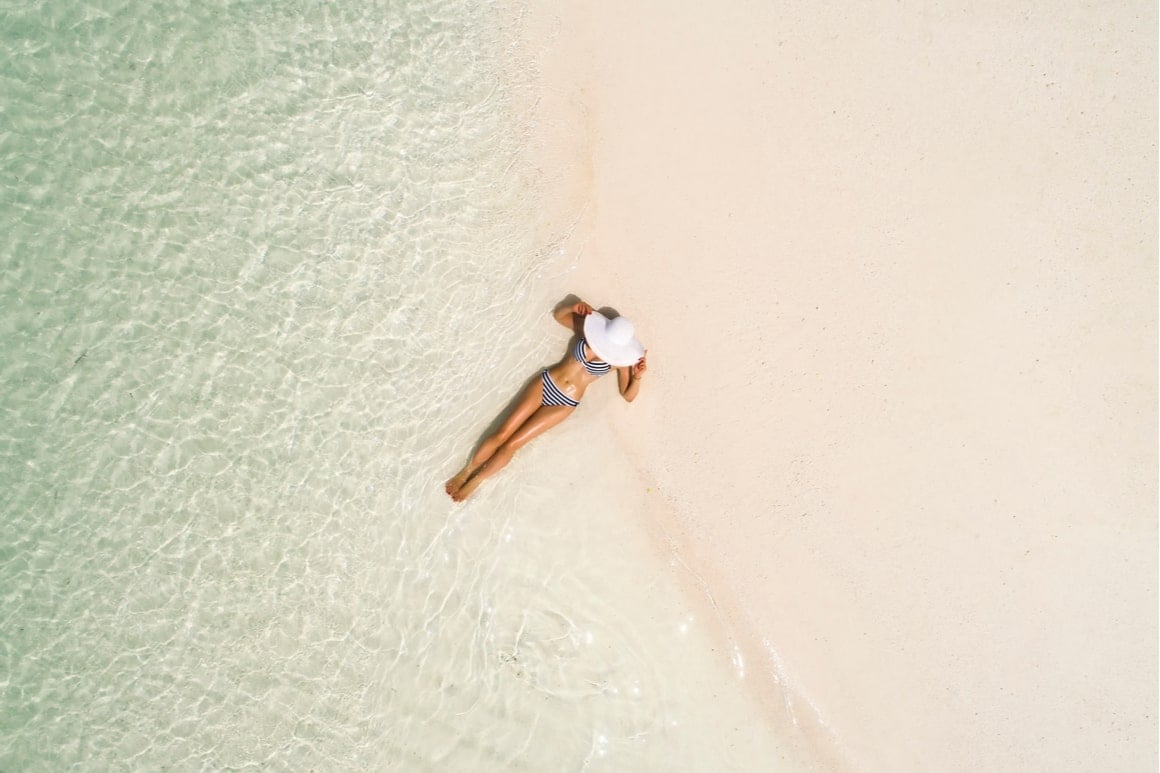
[0,0,802,771]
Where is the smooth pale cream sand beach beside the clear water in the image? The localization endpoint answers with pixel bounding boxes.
[519,0,1158,771]
